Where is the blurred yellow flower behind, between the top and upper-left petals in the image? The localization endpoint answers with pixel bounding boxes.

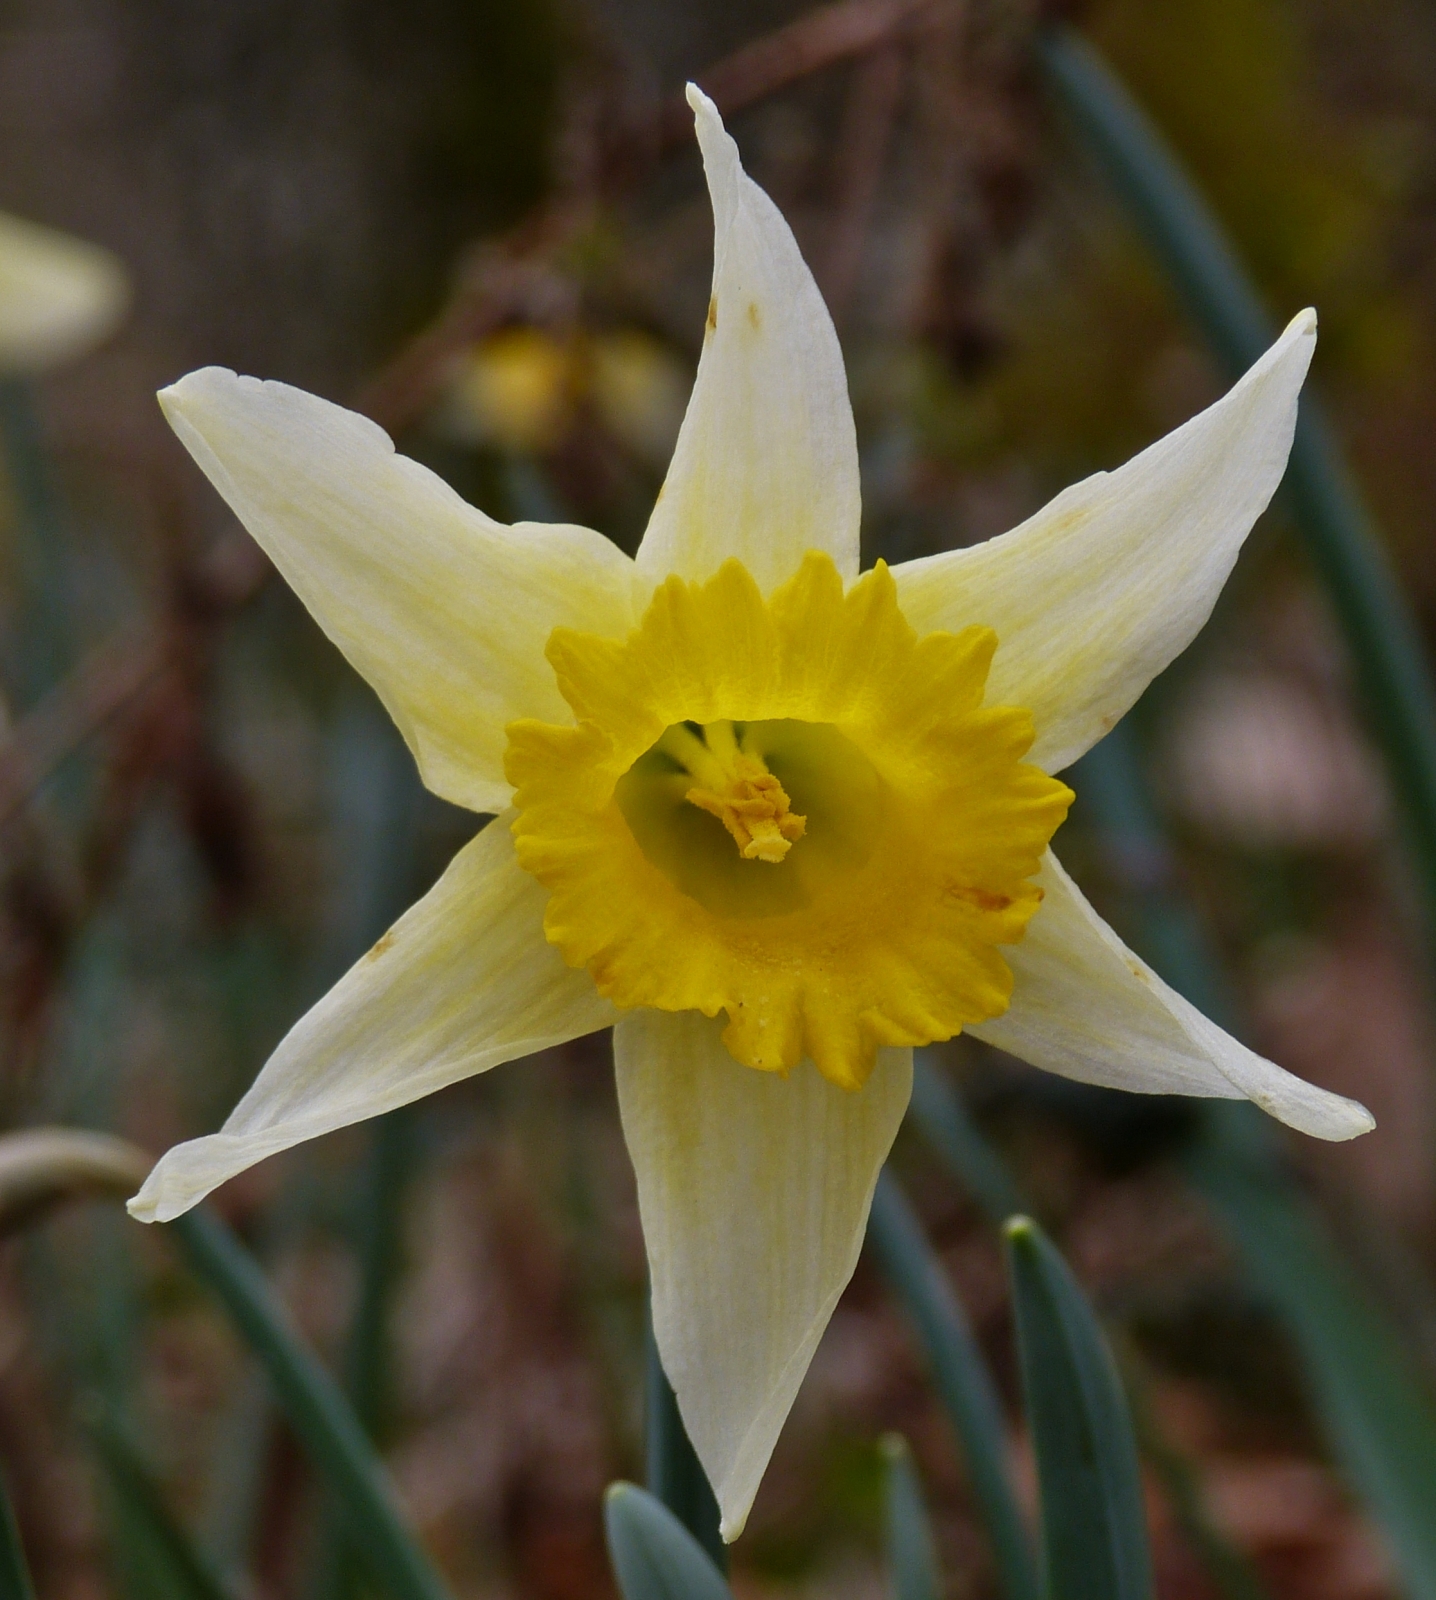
[438,315,684,466]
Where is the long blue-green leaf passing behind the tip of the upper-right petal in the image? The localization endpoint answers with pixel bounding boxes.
[1036,26,1436,946]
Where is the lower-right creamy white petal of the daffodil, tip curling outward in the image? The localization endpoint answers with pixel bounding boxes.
[969,851,1375,1139]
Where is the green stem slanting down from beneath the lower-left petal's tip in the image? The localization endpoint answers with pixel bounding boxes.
[168,1210,449,1600]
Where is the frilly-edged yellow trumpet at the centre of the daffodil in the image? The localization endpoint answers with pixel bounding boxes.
[505,554,1071,1088]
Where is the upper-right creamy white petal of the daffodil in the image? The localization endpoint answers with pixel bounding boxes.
[894,310,1316,773]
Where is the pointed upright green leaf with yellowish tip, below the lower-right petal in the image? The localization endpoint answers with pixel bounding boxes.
[1006,1216,1151,1600]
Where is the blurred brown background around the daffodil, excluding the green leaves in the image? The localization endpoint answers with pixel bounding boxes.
[0,0,1436,1600]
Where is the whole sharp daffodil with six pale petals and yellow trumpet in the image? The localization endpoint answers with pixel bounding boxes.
[131,90,1372,1539]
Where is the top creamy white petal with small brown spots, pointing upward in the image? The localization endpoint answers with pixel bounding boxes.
[638,85,860,592]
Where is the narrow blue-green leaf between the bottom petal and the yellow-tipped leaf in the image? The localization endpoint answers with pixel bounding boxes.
[868,1171,1041,1600]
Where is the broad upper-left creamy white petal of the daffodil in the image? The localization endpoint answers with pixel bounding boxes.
[160,366,636,811]
